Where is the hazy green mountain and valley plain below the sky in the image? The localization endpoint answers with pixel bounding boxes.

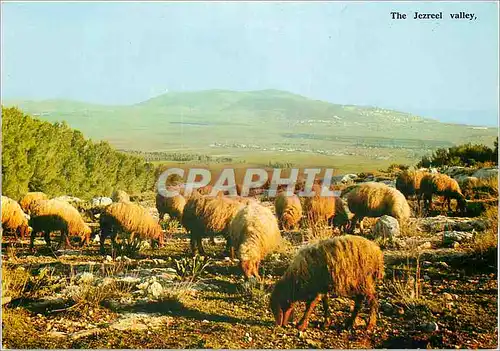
[4,90,497,168]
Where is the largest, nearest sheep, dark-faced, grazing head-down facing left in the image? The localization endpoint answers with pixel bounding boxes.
[270,235,384,331]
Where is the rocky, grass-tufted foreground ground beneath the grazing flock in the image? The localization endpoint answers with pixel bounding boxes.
[2,204,498,349]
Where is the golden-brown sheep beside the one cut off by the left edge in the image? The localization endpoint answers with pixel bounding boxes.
[29,200,92,249]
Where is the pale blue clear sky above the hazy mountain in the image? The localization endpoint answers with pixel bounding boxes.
[1,2,499,125]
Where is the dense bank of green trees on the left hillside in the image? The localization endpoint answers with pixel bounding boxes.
[2,106,155,199]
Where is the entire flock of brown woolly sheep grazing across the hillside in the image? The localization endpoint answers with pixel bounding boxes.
[2,171,465,330]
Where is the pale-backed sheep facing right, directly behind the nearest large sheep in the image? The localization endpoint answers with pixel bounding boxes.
[346,182,411,233]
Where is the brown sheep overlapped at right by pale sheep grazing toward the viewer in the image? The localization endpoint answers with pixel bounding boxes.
[182,192,248,255]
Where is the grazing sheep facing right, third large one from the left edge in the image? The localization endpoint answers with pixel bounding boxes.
[99,202,164,253]
